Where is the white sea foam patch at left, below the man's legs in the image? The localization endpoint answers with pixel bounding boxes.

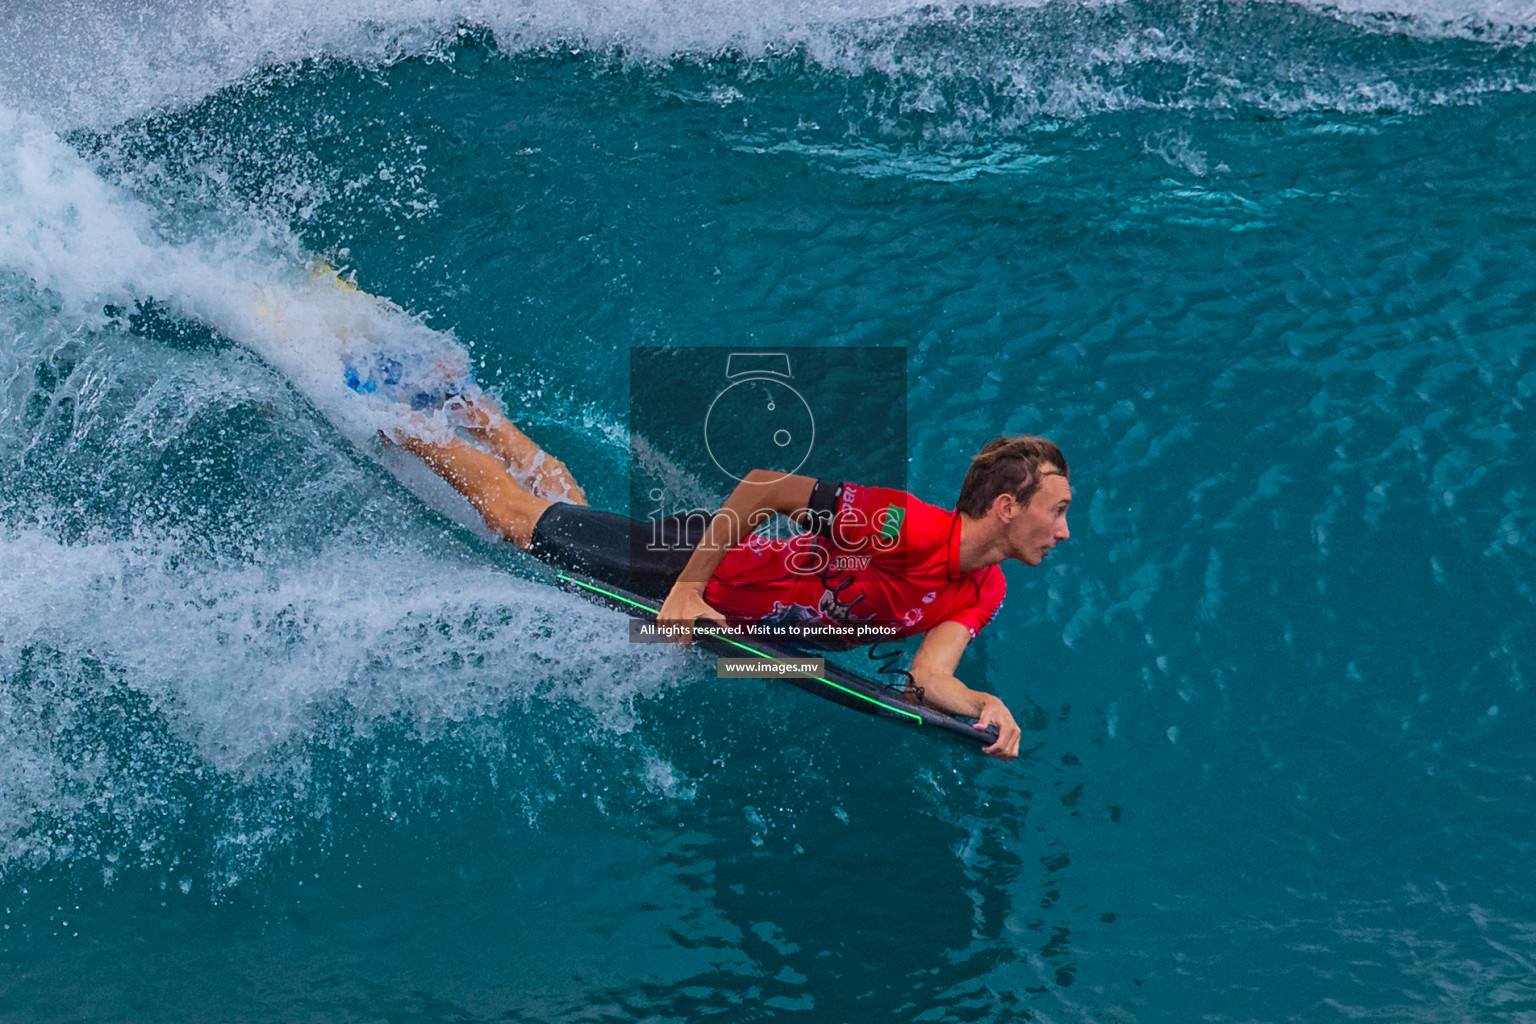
[0,528,676,767]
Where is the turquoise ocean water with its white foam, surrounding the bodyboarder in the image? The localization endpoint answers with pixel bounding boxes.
[0,0,1536,1024]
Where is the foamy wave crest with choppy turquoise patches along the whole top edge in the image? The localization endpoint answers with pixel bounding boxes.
[0,0,1536,129]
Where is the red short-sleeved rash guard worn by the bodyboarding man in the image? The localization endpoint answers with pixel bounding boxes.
[703,482,1006,643]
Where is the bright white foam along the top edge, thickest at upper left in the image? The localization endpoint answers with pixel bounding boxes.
[0,0,1536,127]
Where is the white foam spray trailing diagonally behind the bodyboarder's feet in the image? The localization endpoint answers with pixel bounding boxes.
[0,107,497,445]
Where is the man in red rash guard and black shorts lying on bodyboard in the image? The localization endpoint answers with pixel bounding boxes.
[390,393,1072,760]
